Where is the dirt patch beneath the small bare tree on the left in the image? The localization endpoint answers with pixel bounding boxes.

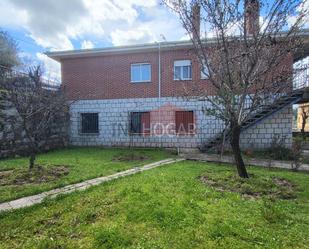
[0,165,69,186]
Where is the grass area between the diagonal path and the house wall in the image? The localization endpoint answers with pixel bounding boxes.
[0,147,171,203]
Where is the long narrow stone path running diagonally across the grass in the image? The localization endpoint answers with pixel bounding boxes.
[0,158,185,212]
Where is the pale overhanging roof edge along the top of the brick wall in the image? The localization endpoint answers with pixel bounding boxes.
[45,29,309,62]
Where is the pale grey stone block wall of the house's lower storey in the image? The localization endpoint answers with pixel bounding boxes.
[70,97,292,149]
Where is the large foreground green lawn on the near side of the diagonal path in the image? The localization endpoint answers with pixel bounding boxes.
[0,161,309,249]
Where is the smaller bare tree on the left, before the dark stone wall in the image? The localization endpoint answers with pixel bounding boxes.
[2,67,69,170]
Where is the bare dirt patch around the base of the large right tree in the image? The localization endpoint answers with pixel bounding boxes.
[200,175,296,199]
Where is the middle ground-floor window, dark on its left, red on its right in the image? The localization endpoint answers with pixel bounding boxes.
[130,112,150,134]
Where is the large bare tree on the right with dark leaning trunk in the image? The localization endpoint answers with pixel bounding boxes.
[164,0,308,178]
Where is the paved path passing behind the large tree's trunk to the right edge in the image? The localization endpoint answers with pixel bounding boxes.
[182,153,309,171]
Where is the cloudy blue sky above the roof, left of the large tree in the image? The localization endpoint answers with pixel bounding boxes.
[0,0,186,83]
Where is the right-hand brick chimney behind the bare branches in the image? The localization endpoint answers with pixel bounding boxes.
[245,0,260,35]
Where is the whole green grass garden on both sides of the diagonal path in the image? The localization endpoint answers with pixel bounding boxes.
[0,148,309,248]
